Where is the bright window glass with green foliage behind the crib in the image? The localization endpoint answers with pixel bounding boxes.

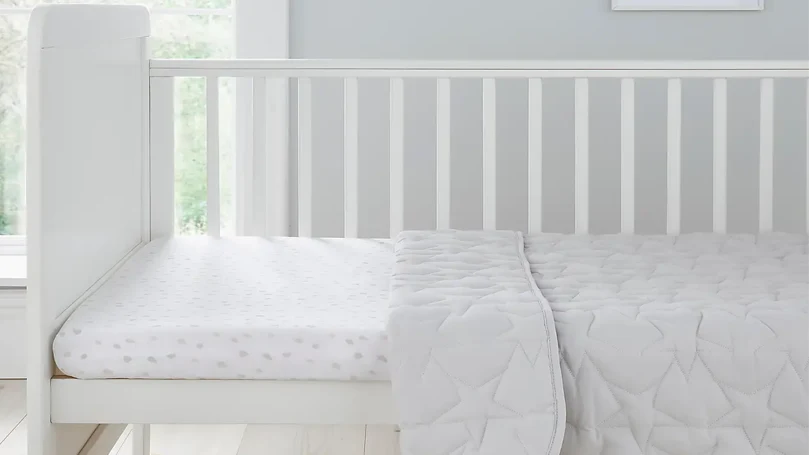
[0,0,235,246]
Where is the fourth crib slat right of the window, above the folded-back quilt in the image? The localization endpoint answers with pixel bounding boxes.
[435,78,452,229]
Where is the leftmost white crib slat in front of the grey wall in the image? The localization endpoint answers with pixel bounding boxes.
[298,77,312,237]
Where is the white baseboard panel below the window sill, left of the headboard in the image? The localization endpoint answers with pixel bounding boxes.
[0,288,25,379]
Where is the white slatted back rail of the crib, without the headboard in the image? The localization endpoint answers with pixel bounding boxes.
[151,60,809,237]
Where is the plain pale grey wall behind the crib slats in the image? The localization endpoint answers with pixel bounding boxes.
[291,0,809,236]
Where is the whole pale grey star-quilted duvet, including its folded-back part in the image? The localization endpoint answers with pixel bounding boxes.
[391,233,809,455]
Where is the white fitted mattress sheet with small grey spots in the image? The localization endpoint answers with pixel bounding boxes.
[53,237,393,380]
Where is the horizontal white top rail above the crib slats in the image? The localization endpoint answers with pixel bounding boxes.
[150,59,809,78]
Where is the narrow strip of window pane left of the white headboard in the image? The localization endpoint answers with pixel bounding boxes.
[0,15,28,235]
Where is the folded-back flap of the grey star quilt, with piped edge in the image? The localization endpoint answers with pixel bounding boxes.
[388,231,565,455]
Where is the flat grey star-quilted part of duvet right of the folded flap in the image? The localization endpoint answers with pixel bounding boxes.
[526,234,809,455]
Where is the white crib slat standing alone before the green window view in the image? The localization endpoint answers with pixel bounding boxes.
[205,76,221,237]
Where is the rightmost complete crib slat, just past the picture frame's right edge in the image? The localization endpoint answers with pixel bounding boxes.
[758,78,774,232]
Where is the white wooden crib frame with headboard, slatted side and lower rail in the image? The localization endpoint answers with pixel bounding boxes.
[27,5,809,455]
